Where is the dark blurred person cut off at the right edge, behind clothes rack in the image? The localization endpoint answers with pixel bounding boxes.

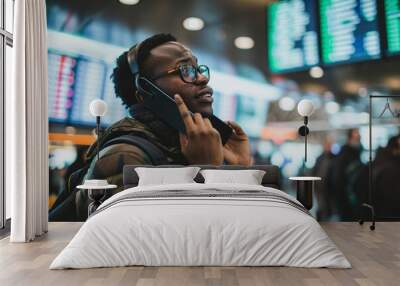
[373,135,400,217]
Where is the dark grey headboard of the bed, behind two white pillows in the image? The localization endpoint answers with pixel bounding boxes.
[123,165,281,189]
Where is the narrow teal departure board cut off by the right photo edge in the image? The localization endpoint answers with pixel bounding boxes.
[384,0,400,55]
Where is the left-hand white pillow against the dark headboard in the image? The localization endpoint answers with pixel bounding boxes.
[135,167,200,186]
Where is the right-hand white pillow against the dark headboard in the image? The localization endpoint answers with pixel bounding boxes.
[200,169,265,185]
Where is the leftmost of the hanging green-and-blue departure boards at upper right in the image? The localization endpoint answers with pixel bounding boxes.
[267,0,319,73]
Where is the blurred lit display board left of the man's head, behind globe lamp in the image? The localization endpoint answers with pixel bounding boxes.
[48,51,127,126]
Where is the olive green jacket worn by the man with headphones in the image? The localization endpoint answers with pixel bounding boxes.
[75,107,187,221]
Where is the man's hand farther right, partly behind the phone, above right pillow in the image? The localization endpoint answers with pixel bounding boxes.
[223,121,252,166]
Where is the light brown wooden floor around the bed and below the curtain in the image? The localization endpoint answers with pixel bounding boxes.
[0,222,400,286]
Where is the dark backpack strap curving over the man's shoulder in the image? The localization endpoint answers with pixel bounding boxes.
[101,134,168,165]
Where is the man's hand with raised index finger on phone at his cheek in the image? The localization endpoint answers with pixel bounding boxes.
[175,94,224,165]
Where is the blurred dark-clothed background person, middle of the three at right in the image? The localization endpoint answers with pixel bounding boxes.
[330,129,363,221]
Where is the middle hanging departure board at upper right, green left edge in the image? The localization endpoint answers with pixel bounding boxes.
[320,0,381,64]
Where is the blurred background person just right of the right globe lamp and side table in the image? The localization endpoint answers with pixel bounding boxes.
[312,135,336,221]
